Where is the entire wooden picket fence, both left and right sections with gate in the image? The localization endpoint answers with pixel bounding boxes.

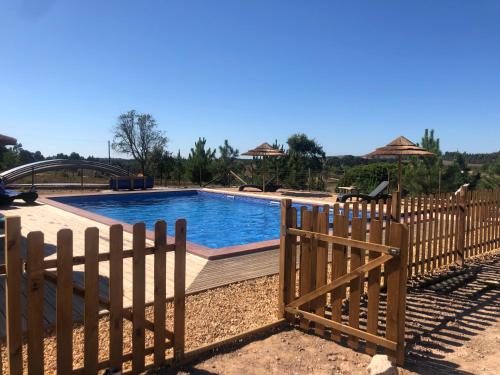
[0,188,500,375]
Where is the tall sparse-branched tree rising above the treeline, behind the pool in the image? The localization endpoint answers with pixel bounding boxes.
[112,110,168,175]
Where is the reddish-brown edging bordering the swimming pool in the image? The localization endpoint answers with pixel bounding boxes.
[38,189,281,260]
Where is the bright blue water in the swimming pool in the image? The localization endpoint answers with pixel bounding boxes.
[54,191,298,248]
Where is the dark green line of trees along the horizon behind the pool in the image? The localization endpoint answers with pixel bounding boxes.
[0,128,500,195]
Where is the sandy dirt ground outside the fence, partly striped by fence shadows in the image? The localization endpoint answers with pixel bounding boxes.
[162,254,500,375]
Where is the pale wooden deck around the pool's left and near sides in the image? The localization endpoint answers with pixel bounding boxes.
[0,204,278,337]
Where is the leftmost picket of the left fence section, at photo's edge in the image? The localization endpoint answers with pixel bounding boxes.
[5,216,23,374]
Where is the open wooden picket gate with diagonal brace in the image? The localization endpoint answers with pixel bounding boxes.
[280,200,408,365]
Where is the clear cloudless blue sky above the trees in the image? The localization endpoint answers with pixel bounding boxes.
[0,0,500,156]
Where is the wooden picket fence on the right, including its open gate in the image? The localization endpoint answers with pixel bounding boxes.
[280,187,500,363]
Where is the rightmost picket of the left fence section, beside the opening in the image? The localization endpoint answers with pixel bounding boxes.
[174,219,186,363]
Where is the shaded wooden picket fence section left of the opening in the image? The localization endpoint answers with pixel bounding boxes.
[0,217,186,374]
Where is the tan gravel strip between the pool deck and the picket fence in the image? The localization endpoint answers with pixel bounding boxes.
[2,276,278,374]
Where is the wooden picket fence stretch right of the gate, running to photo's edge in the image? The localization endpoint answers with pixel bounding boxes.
[401,187,500,276]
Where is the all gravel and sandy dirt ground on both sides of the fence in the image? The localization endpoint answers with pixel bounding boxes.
[2,253,500,374]
